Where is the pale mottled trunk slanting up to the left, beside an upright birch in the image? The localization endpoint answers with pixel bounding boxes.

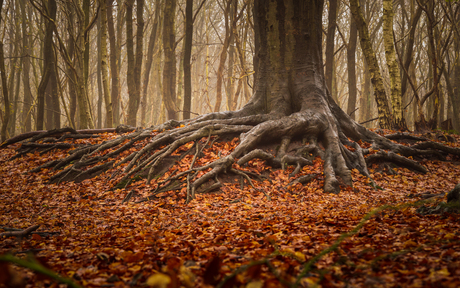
[350,0,393,129]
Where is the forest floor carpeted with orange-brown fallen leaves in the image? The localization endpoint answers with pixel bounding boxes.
[0,131,460,287]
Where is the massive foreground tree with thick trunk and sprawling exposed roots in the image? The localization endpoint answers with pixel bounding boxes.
[26,0,460,201]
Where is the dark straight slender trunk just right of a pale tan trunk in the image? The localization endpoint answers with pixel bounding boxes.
[182,0,193,119]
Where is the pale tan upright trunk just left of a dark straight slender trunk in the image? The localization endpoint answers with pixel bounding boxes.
[162,0,177,119]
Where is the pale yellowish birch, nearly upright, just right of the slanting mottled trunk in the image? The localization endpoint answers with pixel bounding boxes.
[383,0,407,130]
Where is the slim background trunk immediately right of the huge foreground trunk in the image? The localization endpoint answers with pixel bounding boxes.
[324,0,339,104]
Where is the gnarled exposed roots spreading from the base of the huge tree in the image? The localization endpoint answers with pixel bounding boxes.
[4,104,460,201]
